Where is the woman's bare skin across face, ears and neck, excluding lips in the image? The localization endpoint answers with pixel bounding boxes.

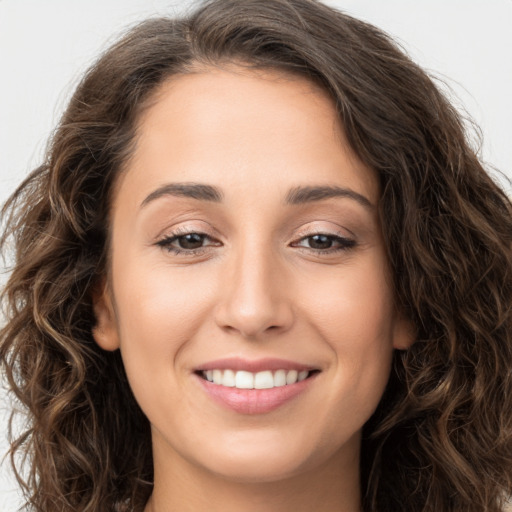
[94,66,412,512]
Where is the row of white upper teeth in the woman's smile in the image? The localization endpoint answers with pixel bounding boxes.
[202,369,309,389]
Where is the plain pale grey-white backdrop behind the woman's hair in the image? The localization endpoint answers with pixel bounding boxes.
[0,0,512,512]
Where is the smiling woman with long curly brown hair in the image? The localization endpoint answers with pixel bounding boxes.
[0,0,512,512]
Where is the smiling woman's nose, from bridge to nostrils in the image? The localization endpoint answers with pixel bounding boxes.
[215,244,294,339]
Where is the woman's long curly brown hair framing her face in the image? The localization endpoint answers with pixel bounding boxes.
[0,0,512,512]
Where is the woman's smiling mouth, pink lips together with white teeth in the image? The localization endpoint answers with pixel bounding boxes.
[194,358,320,414]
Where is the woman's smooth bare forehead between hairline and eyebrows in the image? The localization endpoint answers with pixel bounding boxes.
[117,66,378,210]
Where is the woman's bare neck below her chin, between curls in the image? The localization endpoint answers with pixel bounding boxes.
[145,440,361,512]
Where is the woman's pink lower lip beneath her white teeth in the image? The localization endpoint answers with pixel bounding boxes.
[195,373,318,414]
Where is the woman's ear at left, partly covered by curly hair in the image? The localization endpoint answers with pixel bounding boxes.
[92,282,119,351]
